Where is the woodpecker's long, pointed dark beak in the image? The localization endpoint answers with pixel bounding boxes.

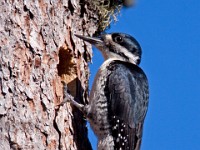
[74,34,103,46]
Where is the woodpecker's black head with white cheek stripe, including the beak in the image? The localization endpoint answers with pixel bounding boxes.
[75,33,142,65]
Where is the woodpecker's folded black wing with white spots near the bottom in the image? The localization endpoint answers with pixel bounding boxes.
[106,62,148,150]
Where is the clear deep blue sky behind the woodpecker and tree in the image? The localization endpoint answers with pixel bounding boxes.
[89,0,200,150]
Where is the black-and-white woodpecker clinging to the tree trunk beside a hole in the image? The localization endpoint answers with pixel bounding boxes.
[63,33,149,150]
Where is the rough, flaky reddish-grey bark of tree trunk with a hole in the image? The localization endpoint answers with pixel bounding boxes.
[0,0,97,150]
